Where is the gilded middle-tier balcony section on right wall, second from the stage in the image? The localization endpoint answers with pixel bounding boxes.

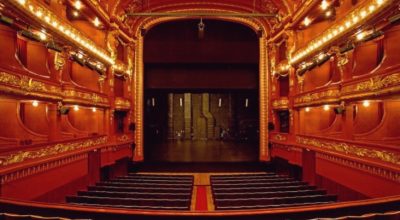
[294,88,340,107]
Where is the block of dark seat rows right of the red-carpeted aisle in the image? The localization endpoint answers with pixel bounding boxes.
[210,173,337,210]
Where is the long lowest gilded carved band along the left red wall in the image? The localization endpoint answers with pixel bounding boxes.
[0,136,107,167]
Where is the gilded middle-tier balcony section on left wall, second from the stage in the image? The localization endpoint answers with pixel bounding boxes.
[62,88,110,107]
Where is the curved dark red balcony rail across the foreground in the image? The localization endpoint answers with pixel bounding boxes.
[0,196,400,220]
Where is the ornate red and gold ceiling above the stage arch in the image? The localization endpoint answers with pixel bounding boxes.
[104,0,304,35]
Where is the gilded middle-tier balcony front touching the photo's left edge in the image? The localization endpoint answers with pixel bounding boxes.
[0,71,62,100]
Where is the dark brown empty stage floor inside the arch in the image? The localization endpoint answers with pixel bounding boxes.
[145,140,259,162]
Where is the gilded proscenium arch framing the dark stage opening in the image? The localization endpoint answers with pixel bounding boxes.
[133,13,270,161]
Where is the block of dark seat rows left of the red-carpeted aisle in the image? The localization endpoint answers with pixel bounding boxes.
[66,174,193,210]
